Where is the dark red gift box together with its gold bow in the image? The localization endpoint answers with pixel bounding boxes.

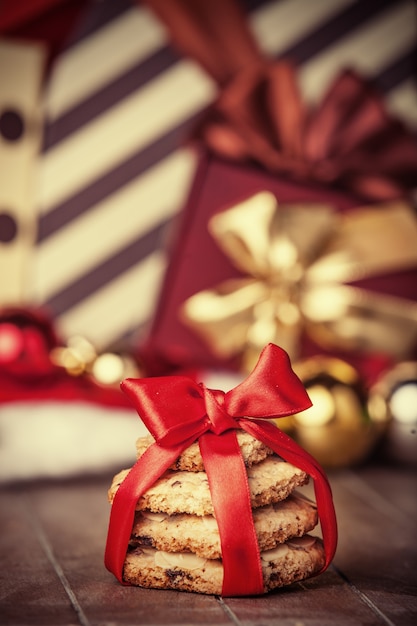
[142,155,417,373]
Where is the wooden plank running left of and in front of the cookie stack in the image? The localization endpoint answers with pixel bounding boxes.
[22,478,231,626]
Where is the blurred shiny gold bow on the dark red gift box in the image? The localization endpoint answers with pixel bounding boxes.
[182,192,417,371]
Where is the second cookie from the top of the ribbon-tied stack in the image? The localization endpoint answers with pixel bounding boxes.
[108,455,308,515]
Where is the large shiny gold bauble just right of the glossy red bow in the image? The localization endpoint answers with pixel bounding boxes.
[277,356,387,468]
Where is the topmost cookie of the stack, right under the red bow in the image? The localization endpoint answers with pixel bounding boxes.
[136,430,273,472]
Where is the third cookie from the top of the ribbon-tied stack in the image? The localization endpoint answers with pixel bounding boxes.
[130,494,317,559]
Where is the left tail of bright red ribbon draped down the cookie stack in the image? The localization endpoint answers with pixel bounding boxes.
[104,436,195,584]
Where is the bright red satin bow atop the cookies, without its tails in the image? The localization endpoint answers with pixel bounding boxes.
[121,343,311,438]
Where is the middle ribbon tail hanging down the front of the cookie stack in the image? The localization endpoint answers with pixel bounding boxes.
[199,430,264,596]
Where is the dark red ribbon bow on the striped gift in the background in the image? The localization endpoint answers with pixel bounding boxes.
[142,0,417,201]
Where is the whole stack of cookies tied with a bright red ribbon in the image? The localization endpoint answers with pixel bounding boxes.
[105,344,337,596]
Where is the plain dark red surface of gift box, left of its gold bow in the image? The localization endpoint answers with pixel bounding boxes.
[140,154,358,374]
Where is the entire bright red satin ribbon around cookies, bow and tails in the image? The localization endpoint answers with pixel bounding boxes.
[105,344,337,596]
